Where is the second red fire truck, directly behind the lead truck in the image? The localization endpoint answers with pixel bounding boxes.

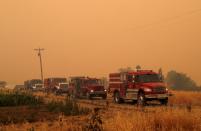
[69,77,107,99]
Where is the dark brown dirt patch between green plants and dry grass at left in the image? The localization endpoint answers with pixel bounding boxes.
[0,106,59,125]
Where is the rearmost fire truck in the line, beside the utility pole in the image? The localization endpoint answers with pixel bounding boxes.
[24,79,43,91]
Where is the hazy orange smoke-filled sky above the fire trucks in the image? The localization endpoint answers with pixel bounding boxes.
[0,0,201,85]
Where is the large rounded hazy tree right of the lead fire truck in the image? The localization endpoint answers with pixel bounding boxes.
[166,70,199,91]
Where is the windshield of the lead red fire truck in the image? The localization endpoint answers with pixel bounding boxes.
[135,74,161,83]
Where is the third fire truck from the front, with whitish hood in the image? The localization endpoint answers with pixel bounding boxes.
[44,78,68,94]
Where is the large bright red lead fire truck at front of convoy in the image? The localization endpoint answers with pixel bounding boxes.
[109,70,168,105]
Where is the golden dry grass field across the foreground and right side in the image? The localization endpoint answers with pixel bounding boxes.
[0,92,201,131]
